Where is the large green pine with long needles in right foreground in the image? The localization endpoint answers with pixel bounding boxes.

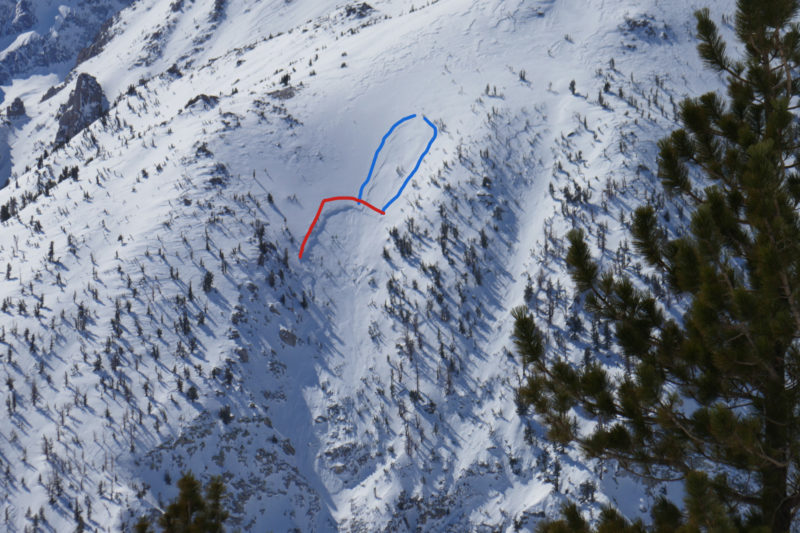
[513,0,800,533]
